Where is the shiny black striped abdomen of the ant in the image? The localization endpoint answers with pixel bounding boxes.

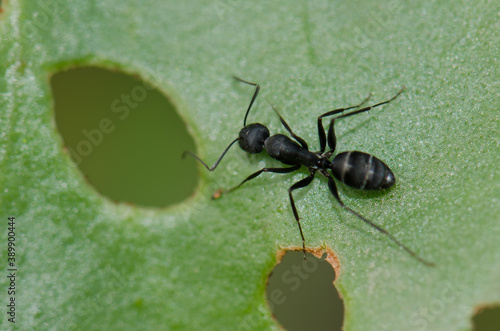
[331,151,396,190]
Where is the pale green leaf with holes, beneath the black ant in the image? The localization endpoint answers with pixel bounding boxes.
[0,0,500,330]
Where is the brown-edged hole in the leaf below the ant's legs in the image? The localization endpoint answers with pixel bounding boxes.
[266,251,344,331]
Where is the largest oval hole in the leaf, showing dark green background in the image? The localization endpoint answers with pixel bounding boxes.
[51,67,198,207]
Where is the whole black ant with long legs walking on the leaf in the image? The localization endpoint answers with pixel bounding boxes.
[183,77,434,266]
